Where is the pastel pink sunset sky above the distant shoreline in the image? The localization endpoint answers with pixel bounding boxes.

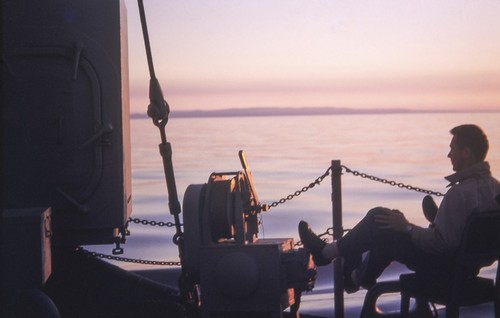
[125,0,500,112]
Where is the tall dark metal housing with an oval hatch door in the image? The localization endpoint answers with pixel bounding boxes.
[0,0,132,245]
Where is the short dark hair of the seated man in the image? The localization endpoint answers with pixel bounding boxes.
[450,125,489,161]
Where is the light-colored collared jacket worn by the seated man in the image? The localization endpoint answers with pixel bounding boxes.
[411,162,500,254]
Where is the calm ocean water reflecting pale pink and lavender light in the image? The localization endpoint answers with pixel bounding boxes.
[89,113,500,314]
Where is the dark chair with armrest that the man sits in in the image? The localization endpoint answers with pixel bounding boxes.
[399,210,500,318]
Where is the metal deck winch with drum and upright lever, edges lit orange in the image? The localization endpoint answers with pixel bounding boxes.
[183,151,316,317]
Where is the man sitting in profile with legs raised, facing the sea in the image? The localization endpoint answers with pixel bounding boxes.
[299,125,500,293]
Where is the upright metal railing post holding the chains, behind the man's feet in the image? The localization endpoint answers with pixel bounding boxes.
[331,160,344,318]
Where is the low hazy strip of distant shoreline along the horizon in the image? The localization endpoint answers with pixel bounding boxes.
[130,107,500,119]
